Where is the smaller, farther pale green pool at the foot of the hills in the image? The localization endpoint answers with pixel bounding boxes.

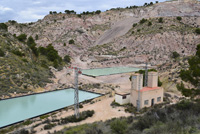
[82,67,140,77]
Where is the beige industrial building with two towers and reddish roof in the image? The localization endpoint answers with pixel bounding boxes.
[115,72,163,109]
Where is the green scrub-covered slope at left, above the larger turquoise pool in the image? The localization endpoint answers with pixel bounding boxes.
[0,29,57,98]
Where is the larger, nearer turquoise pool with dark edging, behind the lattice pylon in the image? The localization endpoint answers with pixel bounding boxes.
[0,88,100,128]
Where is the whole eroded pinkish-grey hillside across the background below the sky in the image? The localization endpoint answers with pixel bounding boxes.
[8,1,200,66]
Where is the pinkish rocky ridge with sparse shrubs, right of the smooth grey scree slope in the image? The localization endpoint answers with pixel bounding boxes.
[88,17,200,66]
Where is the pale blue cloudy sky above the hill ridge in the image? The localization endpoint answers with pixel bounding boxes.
[0,0,165,23]
